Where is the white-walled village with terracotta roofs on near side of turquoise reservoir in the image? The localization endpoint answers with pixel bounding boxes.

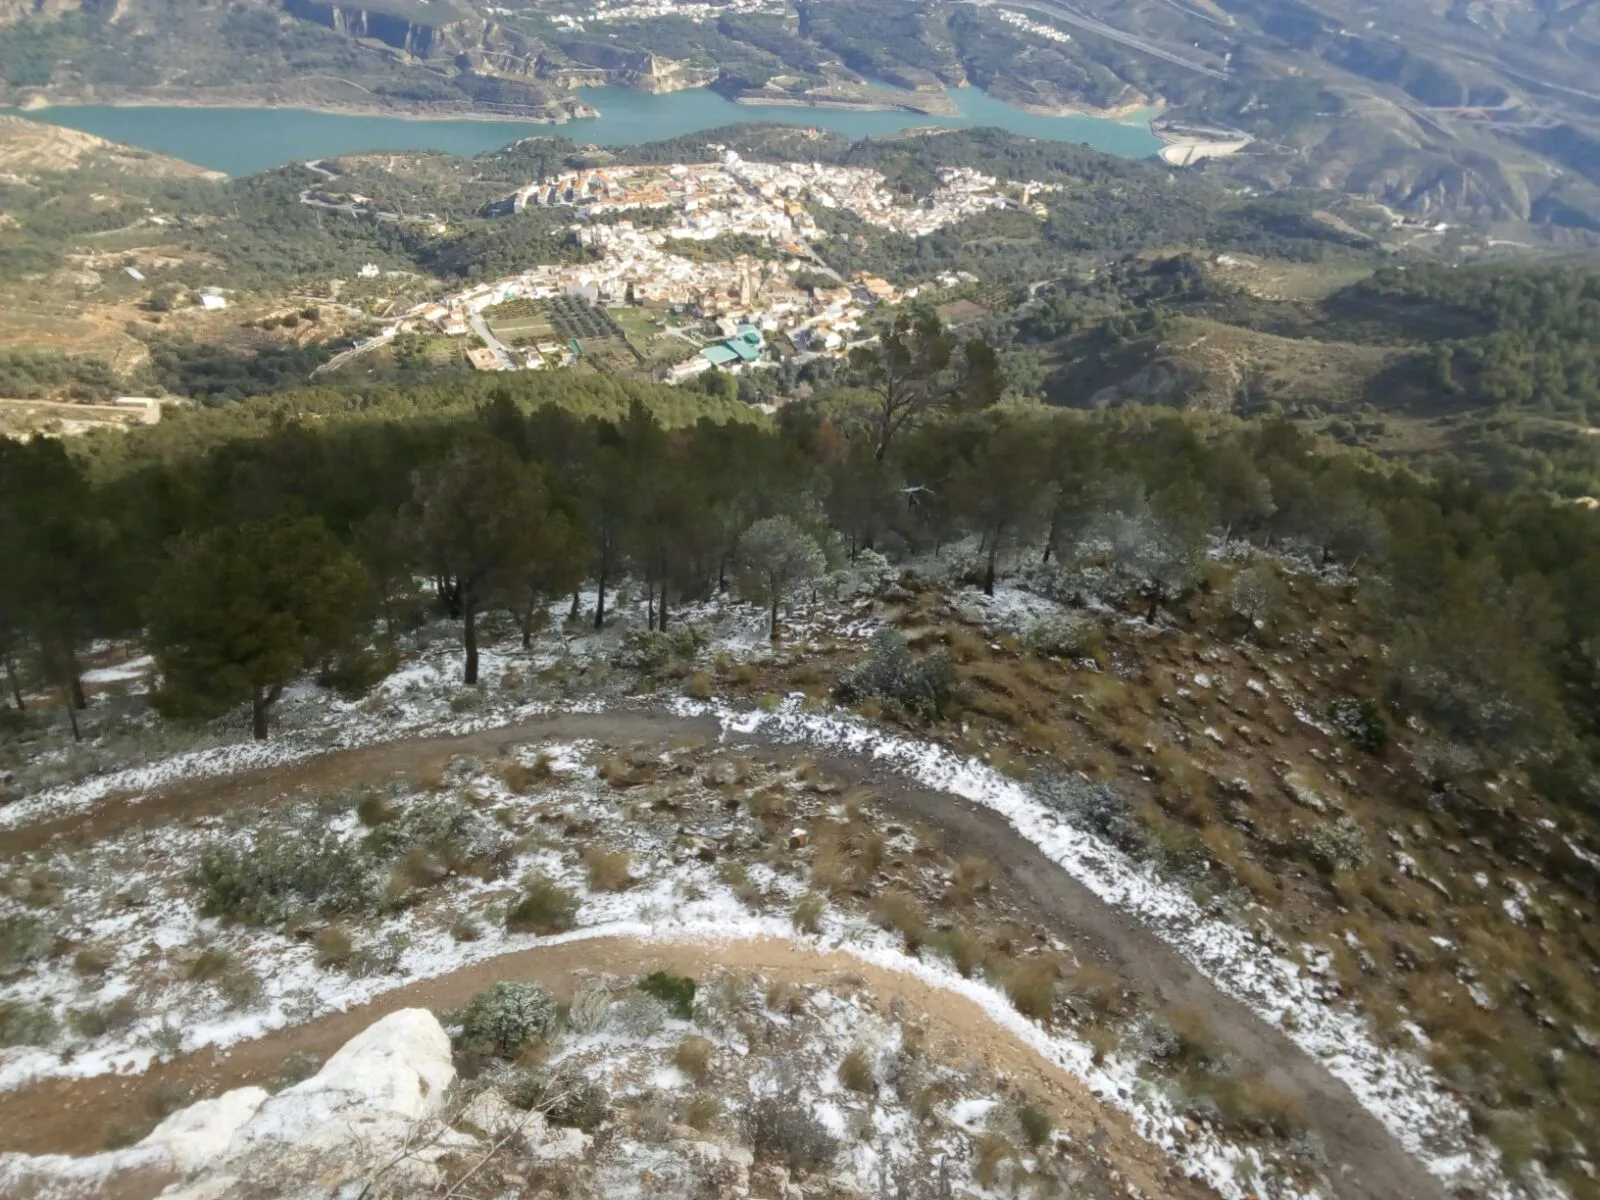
[368,150,1048,382]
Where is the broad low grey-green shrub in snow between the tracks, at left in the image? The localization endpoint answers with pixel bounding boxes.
[190,830,378,925]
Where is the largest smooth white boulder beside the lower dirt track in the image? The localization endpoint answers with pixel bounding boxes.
[229,1008,456,1157]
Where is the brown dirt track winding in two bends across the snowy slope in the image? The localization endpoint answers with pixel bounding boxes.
[0,710,1448,1200]
